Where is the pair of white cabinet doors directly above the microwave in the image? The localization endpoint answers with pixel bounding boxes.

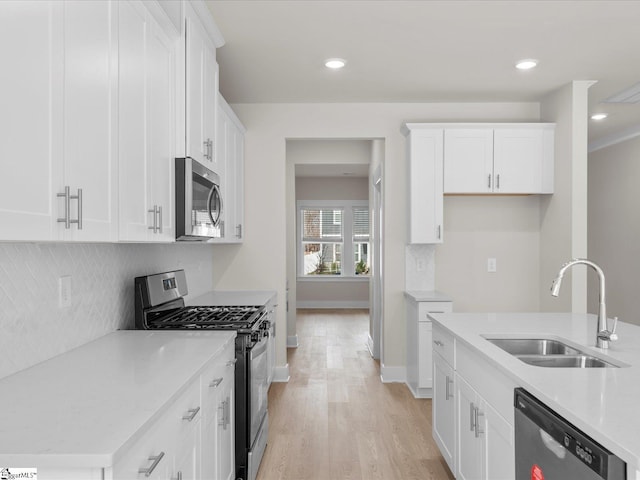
[186,4,222,175]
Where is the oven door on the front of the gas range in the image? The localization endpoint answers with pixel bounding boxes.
[249,336,269,442]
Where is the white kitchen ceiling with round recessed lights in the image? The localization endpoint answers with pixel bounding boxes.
[206,0,640,142]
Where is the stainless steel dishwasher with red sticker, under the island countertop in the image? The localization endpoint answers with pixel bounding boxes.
[514,388,627,480]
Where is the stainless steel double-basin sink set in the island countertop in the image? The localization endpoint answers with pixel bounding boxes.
[485,337,618,368]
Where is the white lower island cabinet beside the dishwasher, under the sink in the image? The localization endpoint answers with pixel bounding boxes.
[433,323,517,480]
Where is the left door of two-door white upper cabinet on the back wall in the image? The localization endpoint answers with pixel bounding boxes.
[444,128,494,193]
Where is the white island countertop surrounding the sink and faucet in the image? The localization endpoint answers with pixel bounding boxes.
[430,313,640,469]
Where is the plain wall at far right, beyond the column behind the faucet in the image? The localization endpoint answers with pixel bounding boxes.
[588,133,640,325]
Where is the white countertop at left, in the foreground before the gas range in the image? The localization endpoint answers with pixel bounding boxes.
[0,330,236,468]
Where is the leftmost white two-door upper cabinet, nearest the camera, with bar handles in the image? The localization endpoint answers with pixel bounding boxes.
[0,1,118,241]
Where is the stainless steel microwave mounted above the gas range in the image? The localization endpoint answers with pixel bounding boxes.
[175,157,222,241]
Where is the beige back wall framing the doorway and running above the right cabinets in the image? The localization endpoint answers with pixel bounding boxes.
[214,103,540,367]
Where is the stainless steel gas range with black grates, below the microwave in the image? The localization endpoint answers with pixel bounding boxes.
[135,270,270,480]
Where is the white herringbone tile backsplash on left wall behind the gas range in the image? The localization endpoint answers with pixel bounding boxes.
[0,243,214,378]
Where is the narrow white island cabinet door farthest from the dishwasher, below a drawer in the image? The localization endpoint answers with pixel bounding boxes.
[432,354,456,472]
